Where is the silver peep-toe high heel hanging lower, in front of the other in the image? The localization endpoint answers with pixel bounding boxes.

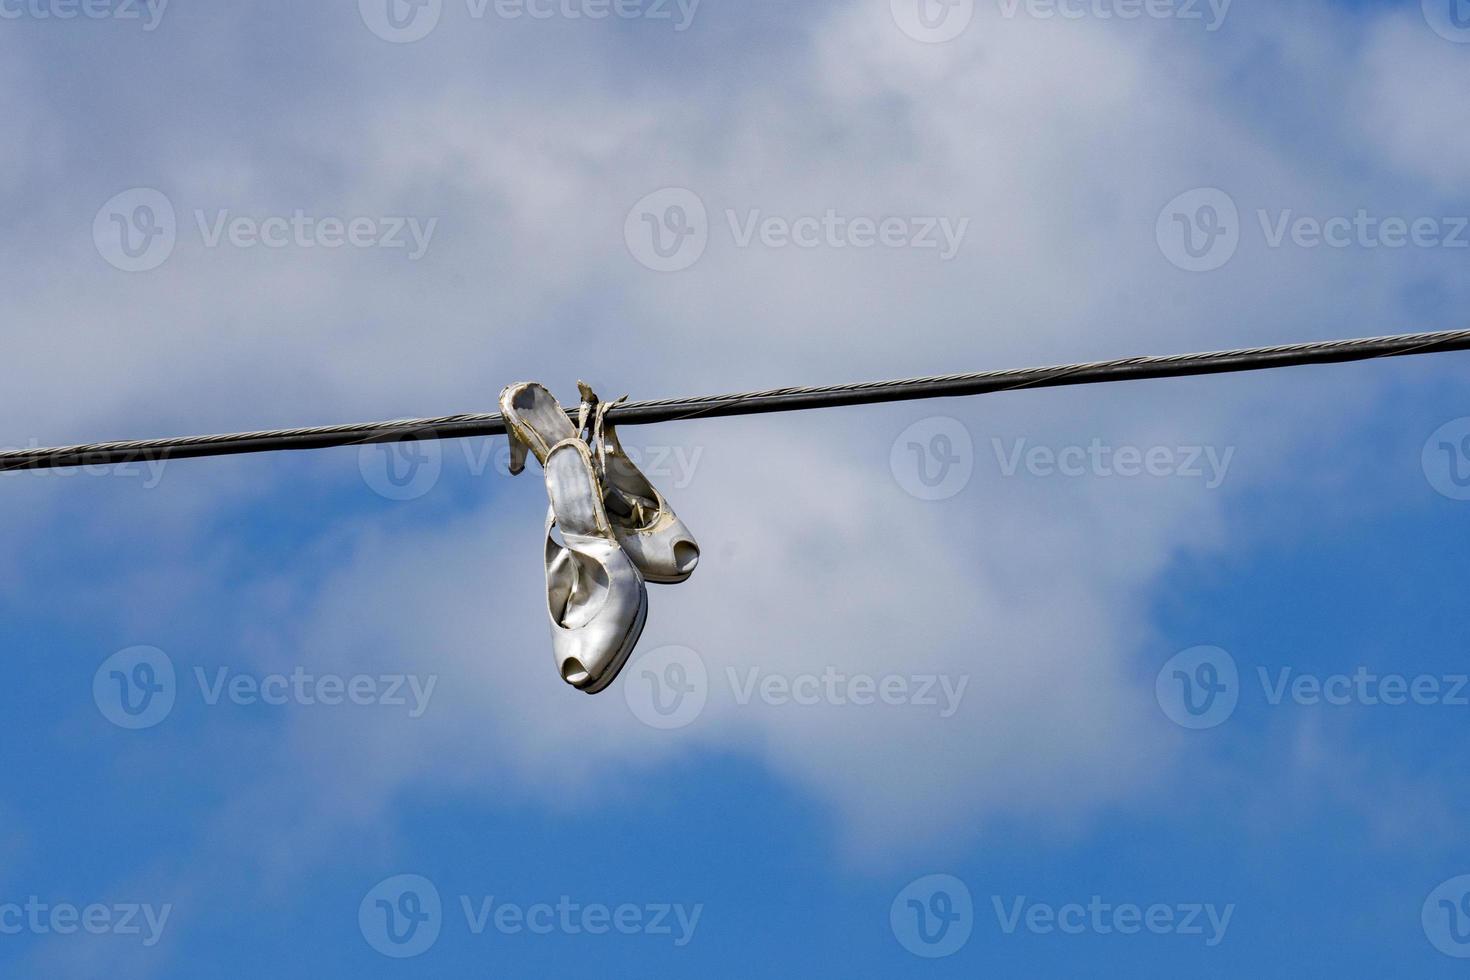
[501,385,648,693]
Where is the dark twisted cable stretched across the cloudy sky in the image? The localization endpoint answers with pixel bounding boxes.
[0,331,1470,472]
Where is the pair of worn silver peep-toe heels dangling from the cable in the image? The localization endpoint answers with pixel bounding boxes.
[500,382,700,693]
